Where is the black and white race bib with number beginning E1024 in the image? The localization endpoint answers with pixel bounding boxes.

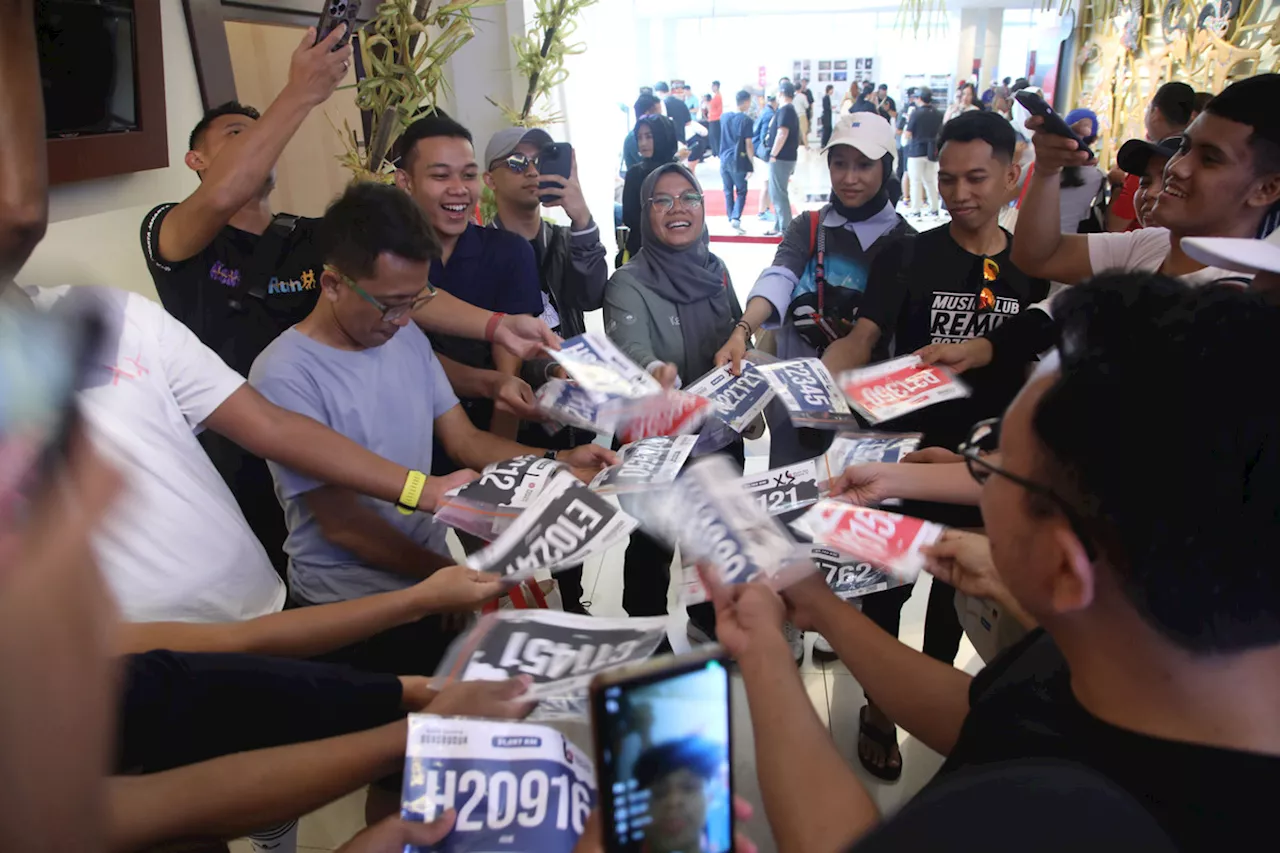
[467,471,636,580]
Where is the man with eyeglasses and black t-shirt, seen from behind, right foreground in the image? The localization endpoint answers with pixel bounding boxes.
[708,273,1280,853]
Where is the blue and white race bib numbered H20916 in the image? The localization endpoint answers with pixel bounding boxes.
[401,713,595,853]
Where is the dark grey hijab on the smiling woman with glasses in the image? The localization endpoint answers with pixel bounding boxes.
[622,163,742,379]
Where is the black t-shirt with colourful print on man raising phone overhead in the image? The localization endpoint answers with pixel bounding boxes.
[142,202,324,375]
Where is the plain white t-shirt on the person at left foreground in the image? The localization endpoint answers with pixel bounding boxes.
[32,287,285,622]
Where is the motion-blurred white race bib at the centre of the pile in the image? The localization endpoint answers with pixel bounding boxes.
[632,456,813,589]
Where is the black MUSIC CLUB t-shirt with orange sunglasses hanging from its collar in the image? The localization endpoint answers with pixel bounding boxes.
[859,225,1048,448]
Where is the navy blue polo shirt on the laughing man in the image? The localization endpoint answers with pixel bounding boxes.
[429,223,543,474]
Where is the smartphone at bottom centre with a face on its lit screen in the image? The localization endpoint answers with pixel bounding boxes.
[591,646,733,853]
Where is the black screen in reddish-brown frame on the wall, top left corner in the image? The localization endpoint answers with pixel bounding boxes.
[36,0,169,183]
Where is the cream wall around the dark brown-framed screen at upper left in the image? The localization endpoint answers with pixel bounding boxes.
[18,0,202,298]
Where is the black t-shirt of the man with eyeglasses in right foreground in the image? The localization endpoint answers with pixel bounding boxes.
[925,630,1280,850]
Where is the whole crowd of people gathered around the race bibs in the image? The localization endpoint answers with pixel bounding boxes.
[0,0,1280,853]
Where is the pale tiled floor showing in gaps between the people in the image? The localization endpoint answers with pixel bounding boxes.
[232,144,967,853]
